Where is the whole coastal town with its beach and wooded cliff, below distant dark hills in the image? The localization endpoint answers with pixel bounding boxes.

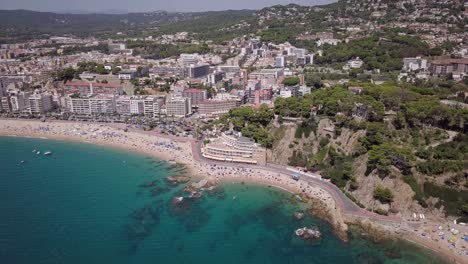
[0,0,468,263]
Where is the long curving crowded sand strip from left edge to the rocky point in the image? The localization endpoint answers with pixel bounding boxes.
[0,119,344,220]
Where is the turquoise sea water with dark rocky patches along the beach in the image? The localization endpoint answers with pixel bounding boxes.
[0,137,441,264]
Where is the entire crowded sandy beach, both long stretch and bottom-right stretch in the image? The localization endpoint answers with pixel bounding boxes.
[0,119,468,263]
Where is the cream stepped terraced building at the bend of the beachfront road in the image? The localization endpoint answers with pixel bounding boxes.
[201,131,263,164]
